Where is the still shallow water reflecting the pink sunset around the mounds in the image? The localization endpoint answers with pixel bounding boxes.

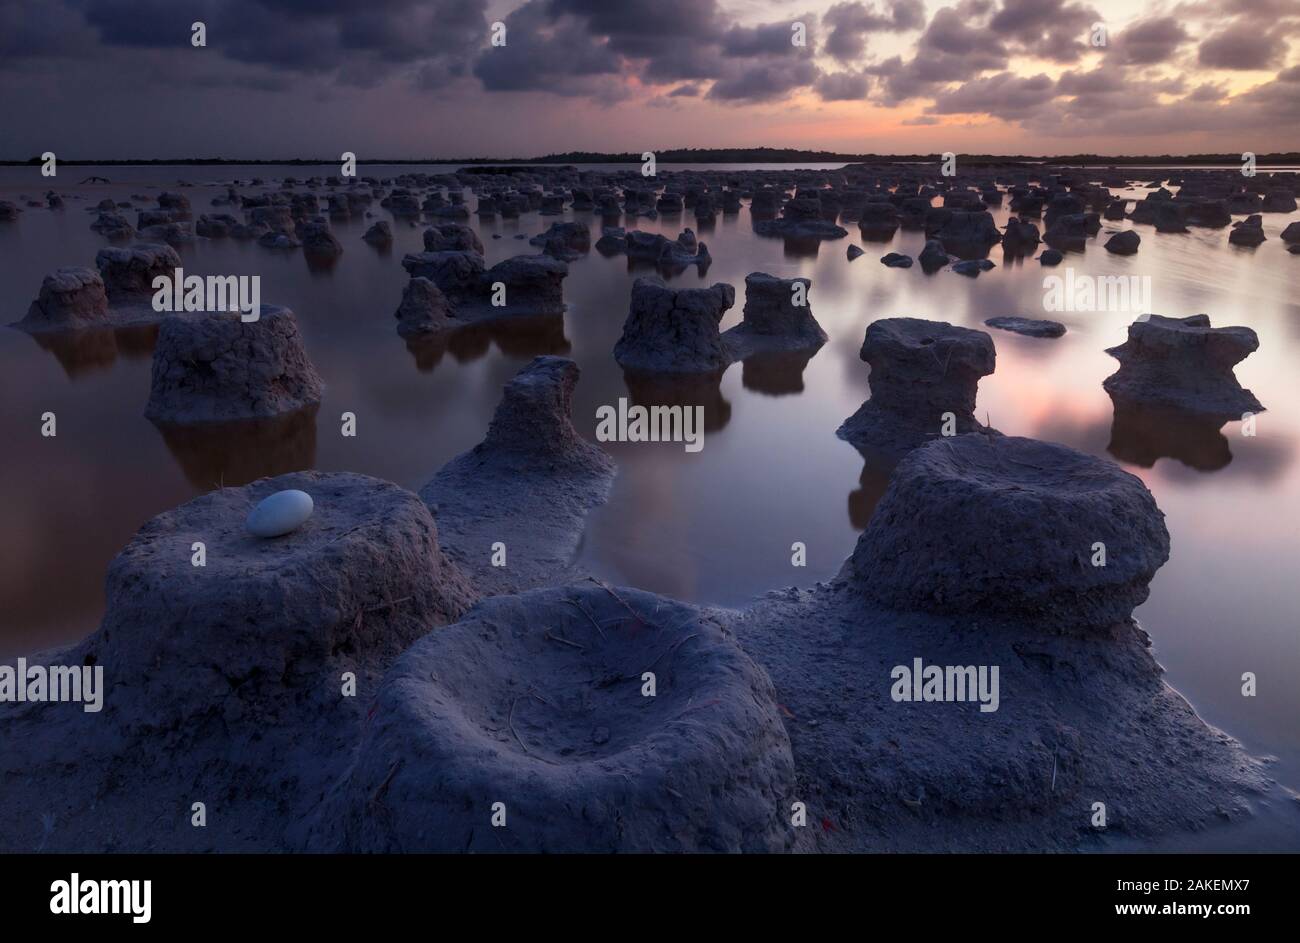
[0,165,1300,832]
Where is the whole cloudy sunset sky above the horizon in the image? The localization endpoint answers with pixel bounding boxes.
[0,0,1300,159]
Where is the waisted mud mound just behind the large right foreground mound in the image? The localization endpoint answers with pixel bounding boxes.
[836,317,997,459]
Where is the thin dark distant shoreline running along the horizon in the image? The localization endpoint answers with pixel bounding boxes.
[0,147,1300,166]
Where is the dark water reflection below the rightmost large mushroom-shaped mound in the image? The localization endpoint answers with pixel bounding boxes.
[1106,397,1232,472]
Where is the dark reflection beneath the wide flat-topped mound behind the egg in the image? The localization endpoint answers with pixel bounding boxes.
[157,406,316,490]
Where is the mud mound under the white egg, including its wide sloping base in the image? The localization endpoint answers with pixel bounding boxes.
[0,472,473,851]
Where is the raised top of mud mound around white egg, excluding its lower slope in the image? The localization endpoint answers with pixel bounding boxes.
[81,472,473,727]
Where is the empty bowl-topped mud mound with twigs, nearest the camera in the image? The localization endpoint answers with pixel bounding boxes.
[316,585,796,852]
